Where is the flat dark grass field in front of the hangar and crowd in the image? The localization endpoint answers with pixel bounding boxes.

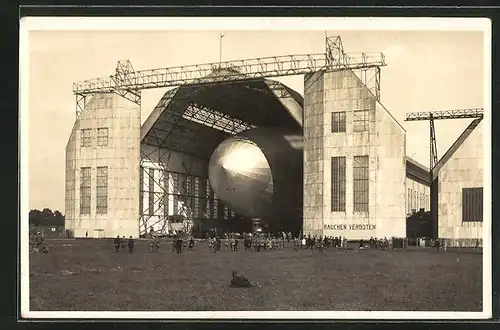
[30,239,482,311]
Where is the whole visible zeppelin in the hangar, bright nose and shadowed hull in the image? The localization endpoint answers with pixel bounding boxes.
[209,127,303,233]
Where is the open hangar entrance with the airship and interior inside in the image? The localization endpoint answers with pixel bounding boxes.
[139,79,302,235]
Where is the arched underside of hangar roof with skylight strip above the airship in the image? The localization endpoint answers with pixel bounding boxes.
[141,79,303,160]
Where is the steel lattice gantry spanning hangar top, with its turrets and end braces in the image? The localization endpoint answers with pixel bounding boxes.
[73,36,386,116]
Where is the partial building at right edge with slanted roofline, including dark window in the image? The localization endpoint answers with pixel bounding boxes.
[432,118,484,244]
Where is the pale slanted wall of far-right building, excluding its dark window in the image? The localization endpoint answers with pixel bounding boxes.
[438,122,484,239]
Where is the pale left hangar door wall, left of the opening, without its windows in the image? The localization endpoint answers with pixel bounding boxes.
[66,93,141,237]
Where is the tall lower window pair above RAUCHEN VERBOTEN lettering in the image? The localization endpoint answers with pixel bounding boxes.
[331,156,370,212]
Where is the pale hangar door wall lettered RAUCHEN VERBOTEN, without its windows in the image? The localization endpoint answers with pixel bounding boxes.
[303,71,406,239]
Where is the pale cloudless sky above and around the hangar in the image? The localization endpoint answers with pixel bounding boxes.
[25,23,485,213]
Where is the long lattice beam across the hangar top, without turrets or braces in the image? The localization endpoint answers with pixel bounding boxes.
[73,53,385,94]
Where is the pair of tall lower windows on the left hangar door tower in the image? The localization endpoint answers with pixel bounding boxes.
[80,166,108,215]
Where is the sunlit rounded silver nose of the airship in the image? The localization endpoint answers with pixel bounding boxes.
[209,137,273,217]
